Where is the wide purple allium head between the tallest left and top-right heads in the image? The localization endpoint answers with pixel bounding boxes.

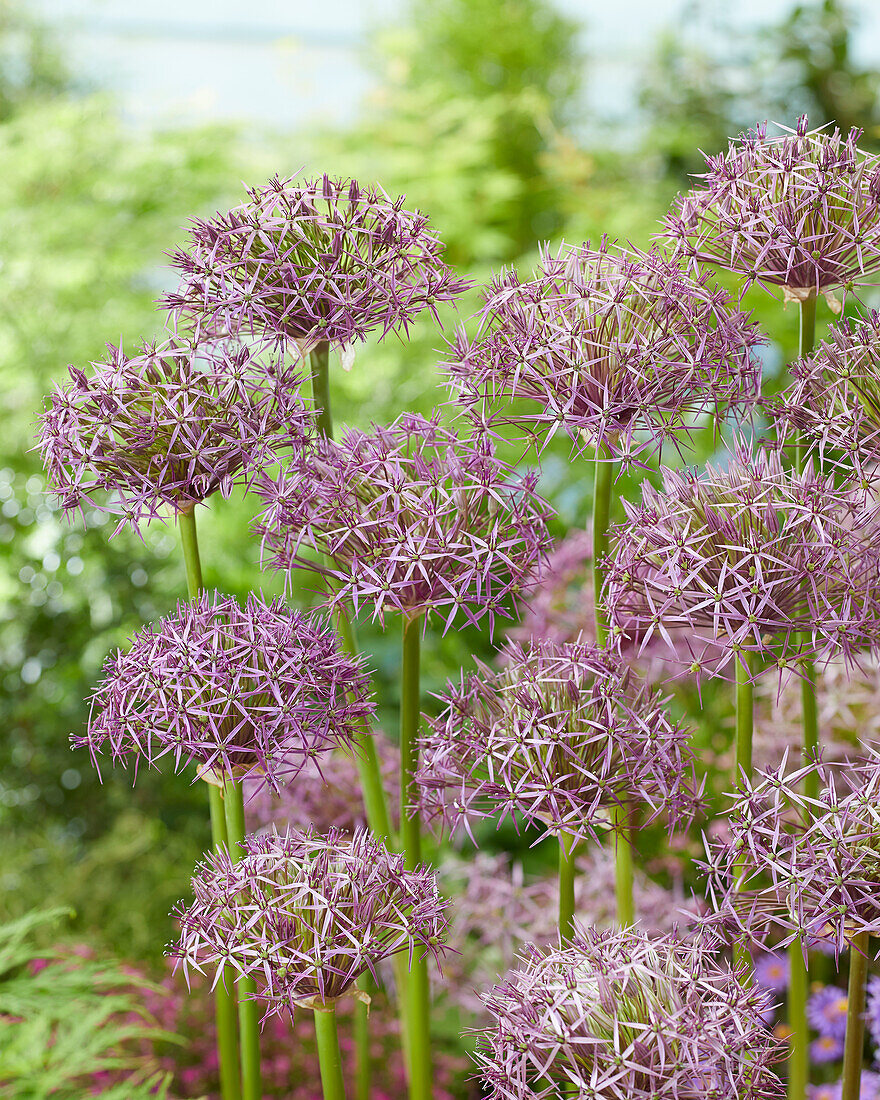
[447,241,761,464]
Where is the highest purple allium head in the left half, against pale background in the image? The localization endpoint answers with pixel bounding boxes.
[166,176,469,351]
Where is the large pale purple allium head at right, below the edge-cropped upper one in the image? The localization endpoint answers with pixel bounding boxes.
[607,435,880,675]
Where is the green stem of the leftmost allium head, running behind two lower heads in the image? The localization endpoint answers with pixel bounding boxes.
[177,510,241,1100]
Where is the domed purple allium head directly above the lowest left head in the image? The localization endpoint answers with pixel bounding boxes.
[74,593,373,790]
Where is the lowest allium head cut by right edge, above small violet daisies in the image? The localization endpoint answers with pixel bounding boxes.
[703,755,880,955]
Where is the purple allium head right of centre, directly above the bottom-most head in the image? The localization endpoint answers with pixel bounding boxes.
[417,640,697,838]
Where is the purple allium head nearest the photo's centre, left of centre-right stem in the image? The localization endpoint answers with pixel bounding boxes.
[259,414,550,628]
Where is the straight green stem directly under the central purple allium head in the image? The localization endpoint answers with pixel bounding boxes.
[400,614,432,1100]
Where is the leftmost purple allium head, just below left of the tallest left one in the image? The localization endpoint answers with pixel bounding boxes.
[40,337,310,530]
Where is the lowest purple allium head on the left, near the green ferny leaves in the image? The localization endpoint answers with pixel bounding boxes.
[173,829,446,1014]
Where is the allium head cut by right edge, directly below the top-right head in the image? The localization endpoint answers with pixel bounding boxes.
[774,310,880,481]
